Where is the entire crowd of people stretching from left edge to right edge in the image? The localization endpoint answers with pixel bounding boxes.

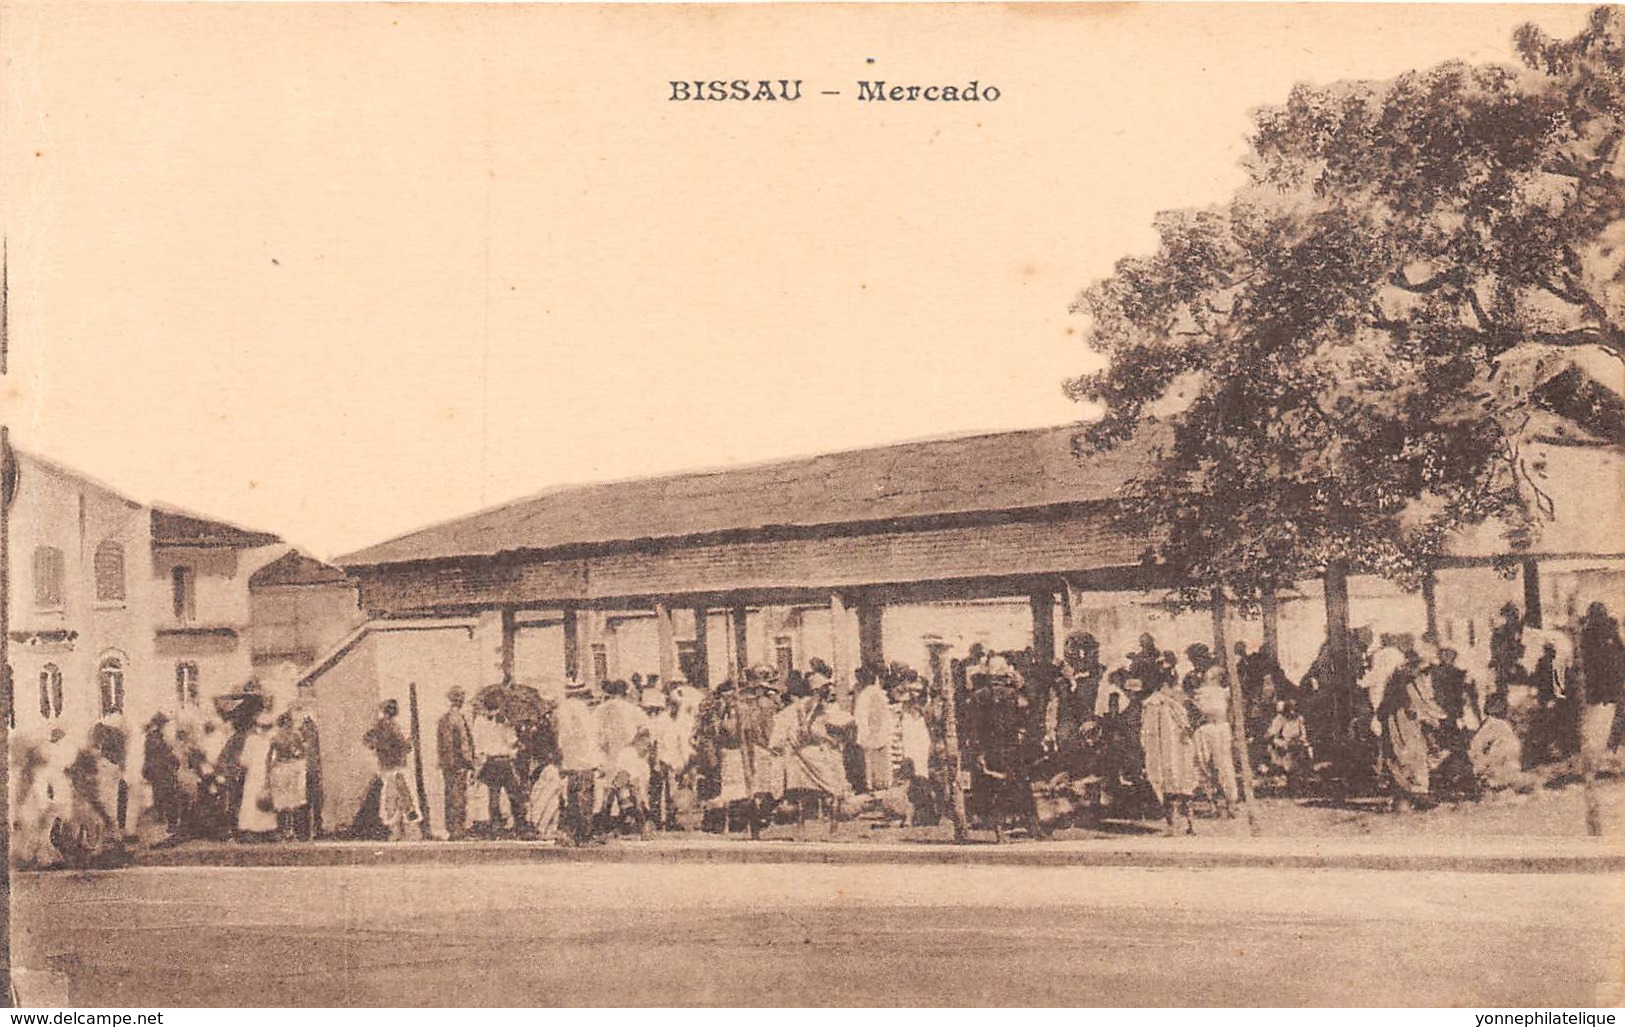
[13,603,1625,865]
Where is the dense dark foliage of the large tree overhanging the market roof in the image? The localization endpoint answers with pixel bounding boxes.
[1068,8,1625,603]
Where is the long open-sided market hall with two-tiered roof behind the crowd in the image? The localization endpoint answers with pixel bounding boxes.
[301,426,1625,827]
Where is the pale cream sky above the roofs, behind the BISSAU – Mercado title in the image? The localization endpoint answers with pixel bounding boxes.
[0,3,1588,557]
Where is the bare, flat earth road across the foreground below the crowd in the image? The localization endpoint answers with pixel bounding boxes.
[13,863,1625,1008]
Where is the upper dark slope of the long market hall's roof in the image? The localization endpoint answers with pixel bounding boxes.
[335,424,1164,567]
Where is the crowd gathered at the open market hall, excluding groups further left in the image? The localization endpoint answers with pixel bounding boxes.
[336,594,1625,843]
